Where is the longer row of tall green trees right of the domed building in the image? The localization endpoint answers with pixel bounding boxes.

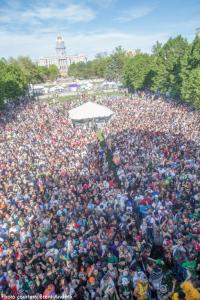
[68,35,200,108]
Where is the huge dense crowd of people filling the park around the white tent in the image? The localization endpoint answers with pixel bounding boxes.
[0,93,200,300]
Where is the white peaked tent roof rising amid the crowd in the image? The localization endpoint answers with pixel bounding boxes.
[69,102,113,120]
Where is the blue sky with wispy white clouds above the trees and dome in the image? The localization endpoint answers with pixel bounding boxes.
[0,0,200,60]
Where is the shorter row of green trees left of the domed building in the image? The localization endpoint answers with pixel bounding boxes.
[0,57,59,107]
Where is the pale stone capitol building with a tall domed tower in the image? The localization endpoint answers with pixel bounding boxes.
[38,36,87,75]
